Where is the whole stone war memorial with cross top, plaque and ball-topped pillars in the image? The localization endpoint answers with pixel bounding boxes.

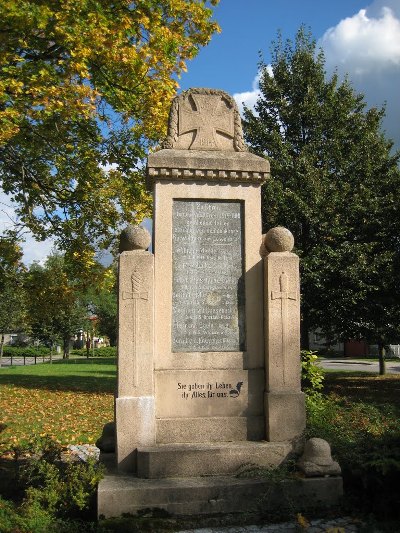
[99,89,341,516]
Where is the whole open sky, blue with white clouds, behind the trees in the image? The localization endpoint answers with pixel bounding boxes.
[0,0,400,263]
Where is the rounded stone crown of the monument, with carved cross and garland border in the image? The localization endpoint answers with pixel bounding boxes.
[164,88,246,152]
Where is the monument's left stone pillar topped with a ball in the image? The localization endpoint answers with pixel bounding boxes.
[115,227,155,472]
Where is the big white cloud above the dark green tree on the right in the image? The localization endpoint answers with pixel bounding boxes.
[318,0,400,148]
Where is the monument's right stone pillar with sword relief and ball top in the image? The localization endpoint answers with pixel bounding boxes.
[264,227,305,442]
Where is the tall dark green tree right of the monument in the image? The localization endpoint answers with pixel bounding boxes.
[244,27,400,372]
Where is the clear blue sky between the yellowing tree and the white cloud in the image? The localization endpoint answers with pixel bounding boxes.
[181,0,370,94]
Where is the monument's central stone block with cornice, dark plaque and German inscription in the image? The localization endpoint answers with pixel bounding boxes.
[148,149,269,444]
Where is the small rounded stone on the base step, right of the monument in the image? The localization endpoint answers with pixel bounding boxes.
[297,437,341,477]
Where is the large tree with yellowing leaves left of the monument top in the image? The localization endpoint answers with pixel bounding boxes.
[0,0,218,249]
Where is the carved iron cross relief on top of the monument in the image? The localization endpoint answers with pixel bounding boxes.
[179,94,234,150]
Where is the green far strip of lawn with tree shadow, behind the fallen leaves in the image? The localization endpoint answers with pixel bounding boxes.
[0,357,117,393]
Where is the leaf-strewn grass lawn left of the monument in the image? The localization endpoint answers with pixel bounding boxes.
[0,358,116,455]
